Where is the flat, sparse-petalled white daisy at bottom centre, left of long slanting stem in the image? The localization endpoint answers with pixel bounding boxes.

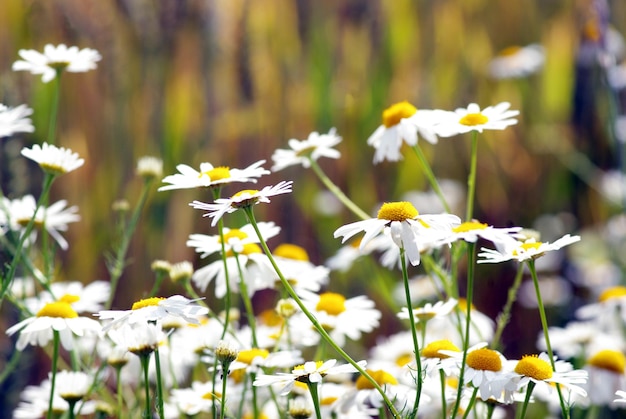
[252,359,367,396]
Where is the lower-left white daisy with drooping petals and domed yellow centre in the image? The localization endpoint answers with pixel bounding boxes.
[6,301,100,351]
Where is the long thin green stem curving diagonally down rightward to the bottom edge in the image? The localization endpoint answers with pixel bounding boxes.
[242,206,399,417]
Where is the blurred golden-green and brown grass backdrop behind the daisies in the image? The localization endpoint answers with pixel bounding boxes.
[0,0,626,370]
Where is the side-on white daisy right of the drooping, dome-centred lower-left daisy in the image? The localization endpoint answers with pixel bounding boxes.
[95,295,209,331]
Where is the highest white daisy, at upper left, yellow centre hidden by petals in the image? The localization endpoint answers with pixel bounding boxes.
[12,44,102,83]
